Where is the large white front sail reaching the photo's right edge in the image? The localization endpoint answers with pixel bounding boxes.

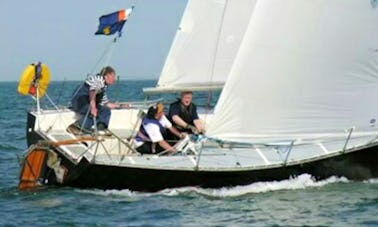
[207,0,378,141]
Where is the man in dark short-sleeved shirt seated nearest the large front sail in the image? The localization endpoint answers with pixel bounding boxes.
[168,91,204,137]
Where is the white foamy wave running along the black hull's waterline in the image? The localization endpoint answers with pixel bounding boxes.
[78,174,350,199]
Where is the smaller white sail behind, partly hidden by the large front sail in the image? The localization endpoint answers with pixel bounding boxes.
[148,0,256,92]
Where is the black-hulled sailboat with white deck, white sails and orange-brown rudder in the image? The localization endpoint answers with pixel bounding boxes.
[20,0,378,191]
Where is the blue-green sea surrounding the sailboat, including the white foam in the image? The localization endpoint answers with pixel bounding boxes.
[0,81,378,226]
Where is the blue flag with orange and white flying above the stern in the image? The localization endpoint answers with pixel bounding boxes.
[95,7,134,35]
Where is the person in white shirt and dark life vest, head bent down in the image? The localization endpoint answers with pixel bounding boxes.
[134,103,185,154]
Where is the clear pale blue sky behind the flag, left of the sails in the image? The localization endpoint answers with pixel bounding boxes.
[0,0,186,81]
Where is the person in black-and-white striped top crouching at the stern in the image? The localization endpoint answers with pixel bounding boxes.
[71,66,128,130]
